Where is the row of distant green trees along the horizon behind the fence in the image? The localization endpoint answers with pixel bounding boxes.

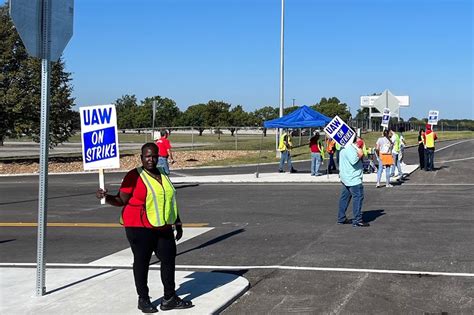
[115,95,351,135]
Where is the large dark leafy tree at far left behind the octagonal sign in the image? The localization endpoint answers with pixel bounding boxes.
[0,3,77,146]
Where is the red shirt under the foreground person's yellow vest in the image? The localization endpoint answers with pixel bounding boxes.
[120,169,153,228]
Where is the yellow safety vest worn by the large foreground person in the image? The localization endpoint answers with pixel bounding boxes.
[137,167,178,227]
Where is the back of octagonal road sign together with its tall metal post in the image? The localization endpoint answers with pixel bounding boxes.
[10,0,74,296]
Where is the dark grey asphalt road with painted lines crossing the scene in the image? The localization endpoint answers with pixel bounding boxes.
[0,139,474,314]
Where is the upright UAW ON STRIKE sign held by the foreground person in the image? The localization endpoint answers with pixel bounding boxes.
[79,105,120,170]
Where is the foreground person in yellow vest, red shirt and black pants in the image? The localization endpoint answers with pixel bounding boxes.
[96,142,193,313]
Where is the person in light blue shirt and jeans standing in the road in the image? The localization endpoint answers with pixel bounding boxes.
[337,137,369,227]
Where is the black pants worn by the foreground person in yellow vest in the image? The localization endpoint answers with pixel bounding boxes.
[125,227,176,299]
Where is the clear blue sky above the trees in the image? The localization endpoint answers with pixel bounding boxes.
[38,0,474,119]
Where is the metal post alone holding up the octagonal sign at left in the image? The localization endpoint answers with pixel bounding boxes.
[36,0,51,296]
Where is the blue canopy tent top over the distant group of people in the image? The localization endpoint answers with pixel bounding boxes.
[263,105,331,128]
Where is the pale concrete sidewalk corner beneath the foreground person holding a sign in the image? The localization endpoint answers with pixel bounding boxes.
[0,228,249,315]
